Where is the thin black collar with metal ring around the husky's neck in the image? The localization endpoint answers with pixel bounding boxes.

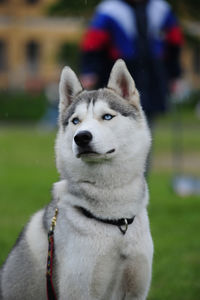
[76,206,135,234]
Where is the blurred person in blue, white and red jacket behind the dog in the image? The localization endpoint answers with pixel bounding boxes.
[81,0,183,126]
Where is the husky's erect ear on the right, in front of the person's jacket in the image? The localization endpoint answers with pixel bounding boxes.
[107,59,139,106]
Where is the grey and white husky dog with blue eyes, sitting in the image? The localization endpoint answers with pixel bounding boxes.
[0,60,153,300]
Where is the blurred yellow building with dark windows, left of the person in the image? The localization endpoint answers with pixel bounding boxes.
[0,0,83,90]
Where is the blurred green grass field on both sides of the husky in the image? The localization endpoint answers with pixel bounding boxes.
[0,121,200,300]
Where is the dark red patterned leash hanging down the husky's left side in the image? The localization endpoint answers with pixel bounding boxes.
[46,208,58,300]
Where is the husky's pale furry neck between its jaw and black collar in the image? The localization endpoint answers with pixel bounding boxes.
[54,172,148,219]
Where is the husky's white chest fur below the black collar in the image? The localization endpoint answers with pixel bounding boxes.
[49,181,153,300]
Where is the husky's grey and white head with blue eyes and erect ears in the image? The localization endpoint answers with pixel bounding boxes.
[56,60,150,178]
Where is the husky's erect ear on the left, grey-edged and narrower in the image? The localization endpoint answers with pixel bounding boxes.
[59,67,83,110]
